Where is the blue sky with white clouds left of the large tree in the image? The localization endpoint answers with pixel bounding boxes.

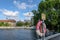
[0,0,41,20]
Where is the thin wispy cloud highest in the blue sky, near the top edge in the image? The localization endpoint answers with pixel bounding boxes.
[13,1,36,9]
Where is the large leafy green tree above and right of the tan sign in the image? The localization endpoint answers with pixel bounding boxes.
[38,0,60,28]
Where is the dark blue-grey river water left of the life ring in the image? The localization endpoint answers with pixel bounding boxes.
[0,29,36,40]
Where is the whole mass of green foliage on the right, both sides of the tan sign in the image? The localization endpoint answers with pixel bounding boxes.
[32,0,60,29]
